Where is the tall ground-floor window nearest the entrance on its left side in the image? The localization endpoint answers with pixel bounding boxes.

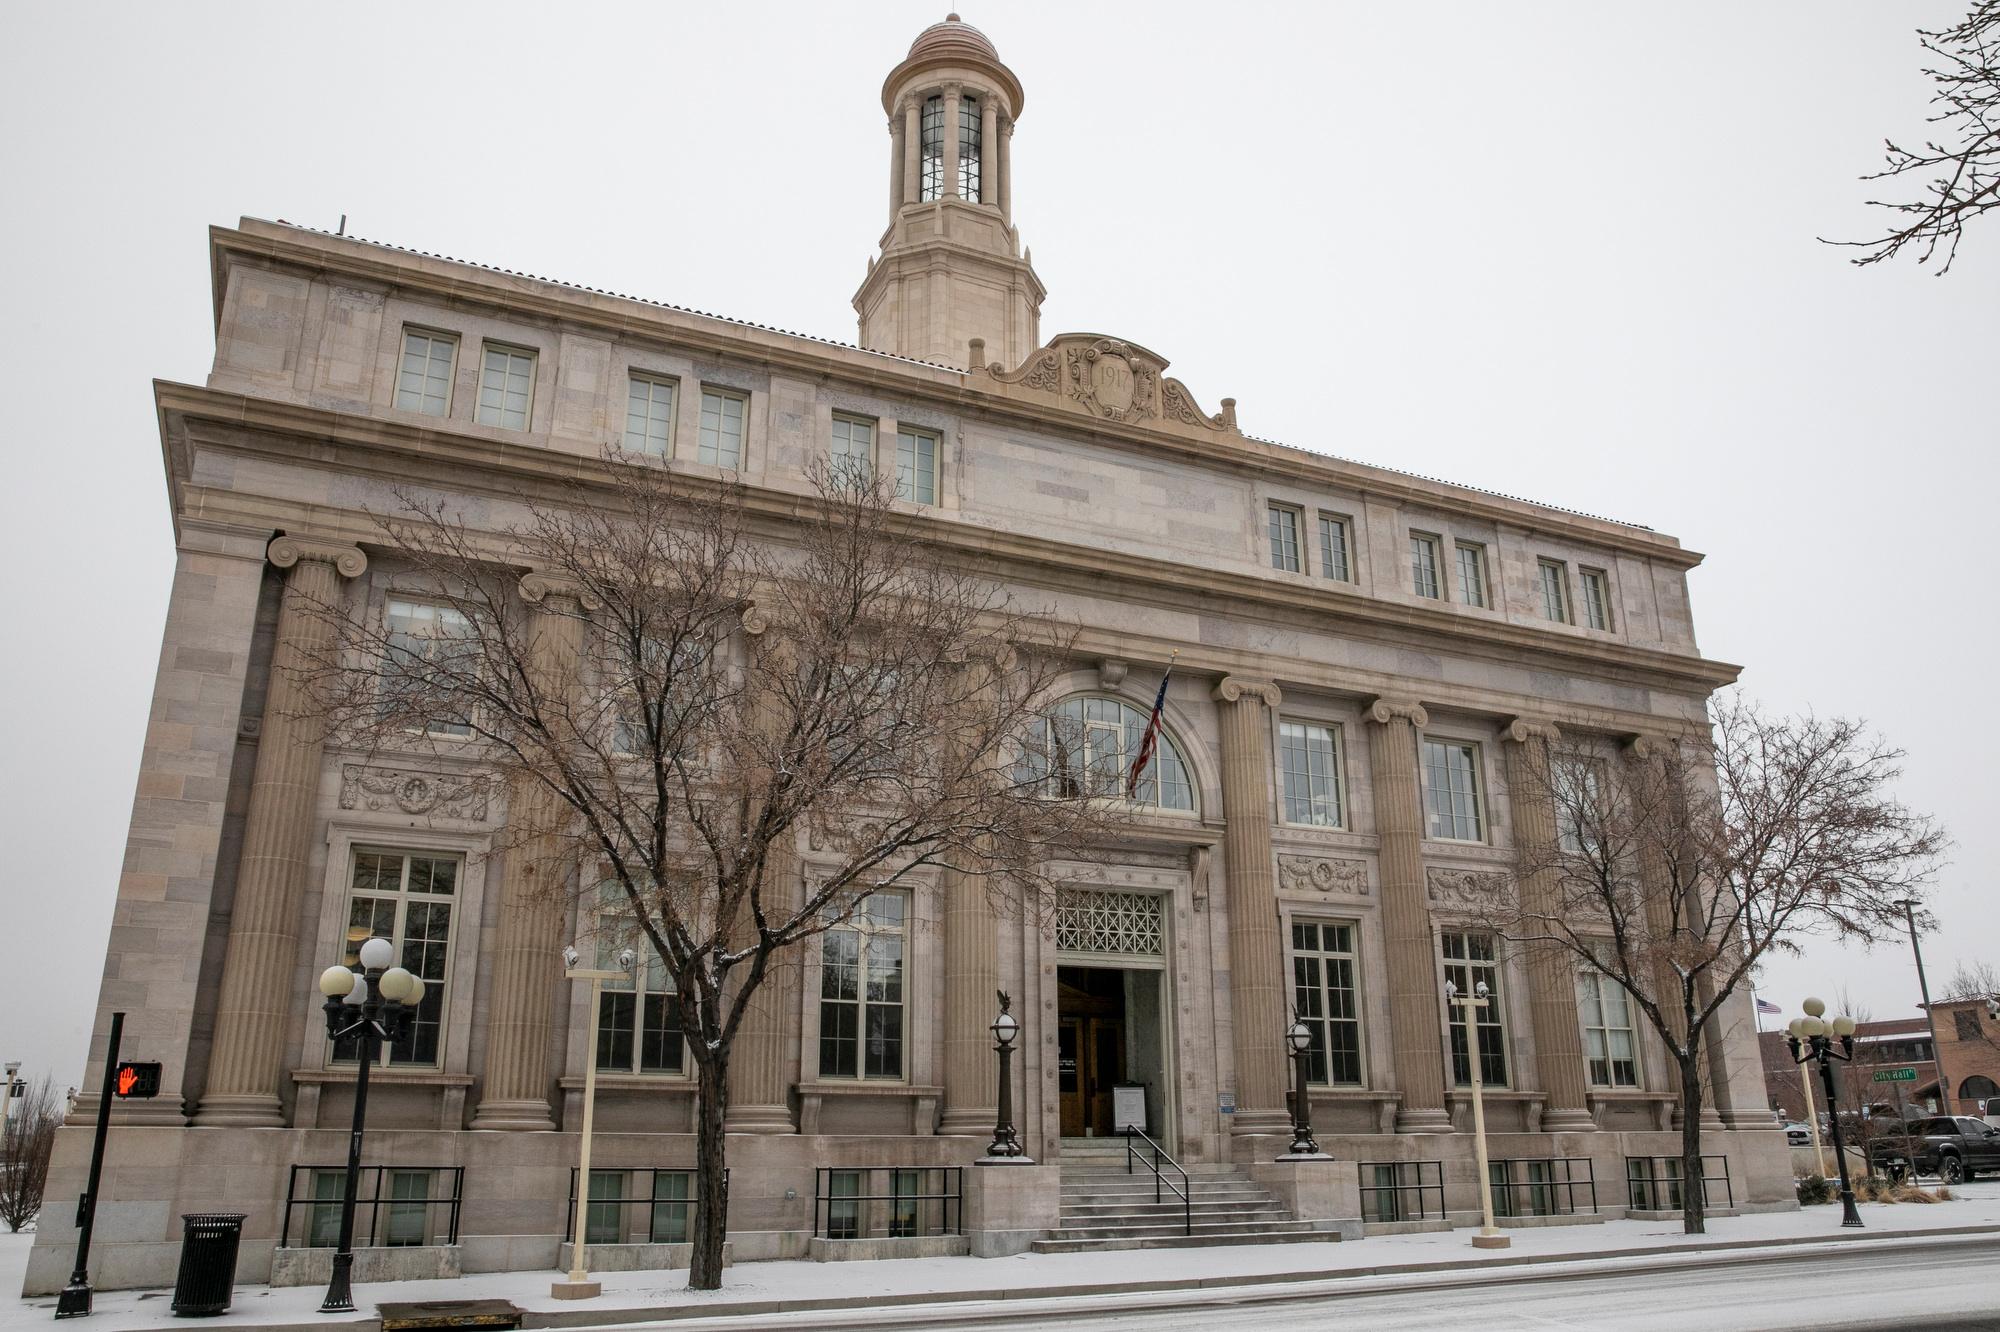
[820,892,908,1078]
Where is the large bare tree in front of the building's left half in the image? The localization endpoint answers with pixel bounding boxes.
[302,454,1122,1290]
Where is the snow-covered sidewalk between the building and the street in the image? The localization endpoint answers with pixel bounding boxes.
[0,1182,2000,1332]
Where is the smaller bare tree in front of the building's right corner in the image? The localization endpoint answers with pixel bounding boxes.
[1494,696,1946,1234]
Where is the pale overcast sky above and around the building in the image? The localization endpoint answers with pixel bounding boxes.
[0,0,2000,1082]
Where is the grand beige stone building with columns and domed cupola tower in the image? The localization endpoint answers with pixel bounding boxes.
[28,16,1792,1292]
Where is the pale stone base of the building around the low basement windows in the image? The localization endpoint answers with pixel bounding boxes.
[22,1124,1798,1296]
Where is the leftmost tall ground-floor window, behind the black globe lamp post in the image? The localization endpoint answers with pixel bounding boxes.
[334,850,460,1066]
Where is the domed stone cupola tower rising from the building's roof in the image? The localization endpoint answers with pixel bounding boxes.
[854,14,1046,366]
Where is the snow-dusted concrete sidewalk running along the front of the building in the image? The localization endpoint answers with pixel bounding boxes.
[15,1182,2000,1332]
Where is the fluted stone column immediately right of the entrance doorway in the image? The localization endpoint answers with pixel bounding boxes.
[1214,676,1290,1134]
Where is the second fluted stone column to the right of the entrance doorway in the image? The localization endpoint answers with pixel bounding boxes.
[1368,698,1452,1134]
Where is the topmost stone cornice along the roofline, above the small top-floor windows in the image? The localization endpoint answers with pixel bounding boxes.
[208,223,1702,568]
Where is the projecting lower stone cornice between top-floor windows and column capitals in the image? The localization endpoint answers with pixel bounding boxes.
[154,382,1740,704]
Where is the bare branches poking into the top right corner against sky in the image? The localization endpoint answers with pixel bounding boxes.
[1828,0,2000,278]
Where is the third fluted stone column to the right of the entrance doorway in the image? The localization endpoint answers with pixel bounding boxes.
[1500,718,1598,1132]
